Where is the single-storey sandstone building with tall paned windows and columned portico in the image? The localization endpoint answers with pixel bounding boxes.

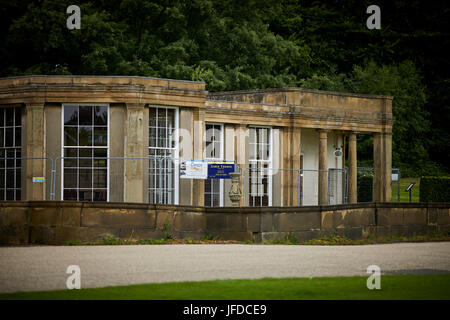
[0,76,392,206]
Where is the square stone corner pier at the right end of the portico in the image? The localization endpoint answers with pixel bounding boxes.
[373,133,392,202]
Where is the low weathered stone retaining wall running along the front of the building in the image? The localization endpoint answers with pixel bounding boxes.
[0,201,450,245]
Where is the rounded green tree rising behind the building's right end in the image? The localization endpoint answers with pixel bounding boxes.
[347,60,430,175]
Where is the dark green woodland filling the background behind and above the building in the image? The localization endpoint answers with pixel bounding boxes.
[0,0,450,176]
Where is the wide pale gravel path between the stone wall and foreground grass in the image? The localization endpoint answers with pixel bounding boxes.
[0,242,450,292]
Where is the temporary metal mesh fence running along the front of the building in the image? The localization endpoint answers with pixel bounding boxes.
[0,156,401,206]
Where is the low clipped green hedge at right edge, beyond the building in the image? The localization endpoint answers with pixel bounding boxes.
[420,177,450,202]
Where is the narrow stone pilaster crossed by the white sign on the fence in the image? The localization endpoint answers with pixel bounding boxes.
[192,108,205,206]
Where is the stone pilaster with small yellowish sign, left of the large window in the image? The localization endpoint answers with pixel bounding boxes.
[22,103,45,200]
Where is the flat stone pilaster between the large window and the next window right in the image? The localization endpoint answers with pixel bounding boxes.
[124,103,143,202]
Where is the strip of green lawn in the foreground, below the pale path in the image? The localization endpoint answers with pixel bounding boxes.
[0,274,450,300]
